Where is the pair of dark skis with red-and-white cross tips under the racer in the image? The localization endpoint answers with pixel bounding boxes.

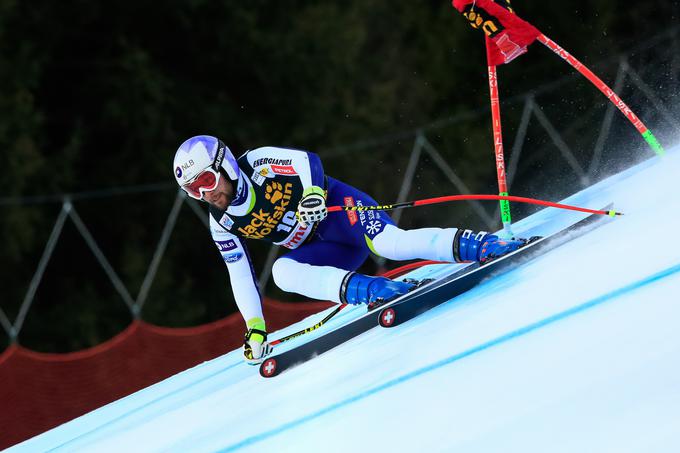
[260,205,611,378]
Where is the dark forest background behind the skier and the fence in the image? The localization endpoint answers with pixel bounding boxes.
[0,0,680,352]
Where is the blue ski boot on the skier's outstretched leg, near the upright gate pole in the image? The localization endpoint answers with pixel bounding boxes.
[453,229,528,264]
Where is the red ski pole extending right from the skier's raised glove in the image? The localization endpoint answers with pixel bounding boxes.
[328,195,623,217]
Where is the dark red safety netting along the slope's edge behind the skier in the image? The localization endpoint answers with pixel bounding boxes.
[0,300,334,450]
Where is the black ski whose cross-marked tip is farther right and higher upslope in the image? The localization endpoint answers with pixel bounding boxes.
[378,205,611,328]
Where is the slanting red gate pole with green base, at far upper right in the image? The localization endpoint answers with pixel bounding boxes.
[538,34,666,156]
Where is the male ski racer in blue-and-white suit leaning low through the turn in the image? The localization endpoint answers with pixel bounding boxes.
[173,135,525,365]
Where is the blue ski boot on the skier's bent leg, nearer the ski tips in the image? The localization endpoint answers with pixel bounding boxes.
[340,272,416,305]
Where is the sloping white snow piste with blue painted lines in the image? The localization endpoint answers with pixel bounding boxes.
[9,143,680,453]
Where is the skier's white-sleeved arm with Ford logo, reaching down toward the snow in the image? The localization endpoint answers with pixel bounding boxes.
[210,216,264,324]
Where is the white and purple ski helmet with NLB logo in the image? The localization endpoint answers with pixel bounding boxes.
[173,135,240,187]
